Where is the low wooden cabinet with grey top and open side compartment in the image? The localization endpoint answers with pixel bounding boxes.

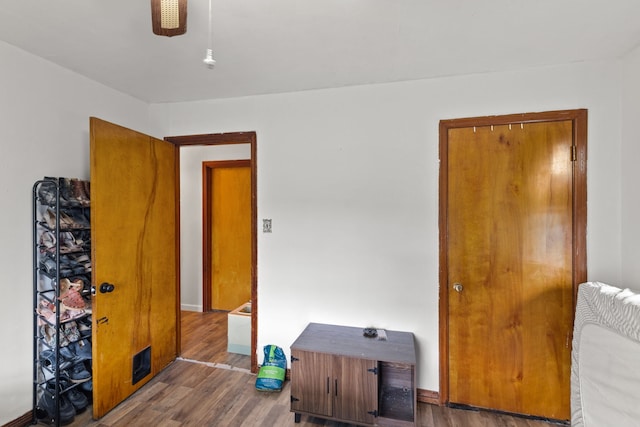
[291,323,416,426]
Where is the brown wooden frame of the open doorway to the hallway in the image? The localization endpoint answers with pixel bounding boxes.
[164,132,258,373]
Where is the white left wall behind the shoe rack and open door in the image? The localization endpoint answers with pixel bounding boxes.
[0,42,152,424]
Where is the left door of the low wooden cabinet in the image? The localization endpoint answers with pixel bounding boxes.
[291,349,333,417]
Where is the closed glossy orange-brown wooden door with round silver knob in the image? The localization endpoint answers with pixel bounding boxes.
[441,111,586,420]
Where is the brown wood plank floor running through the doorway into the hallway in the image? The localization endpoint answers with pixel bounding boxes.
[57,313,556,427]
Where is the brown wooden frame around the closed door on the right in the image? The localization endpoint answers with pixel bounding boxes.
[438,109,587,405]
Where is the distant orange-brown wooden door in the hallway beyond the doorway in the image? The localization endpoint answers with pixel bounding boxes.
[208,160,252,310]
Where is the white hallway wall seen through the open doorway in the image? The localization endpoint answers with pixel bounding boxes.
[180,144,251,311]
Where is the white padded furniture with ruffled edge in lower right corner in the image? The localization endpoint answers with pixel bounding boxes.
[571,282,640,427]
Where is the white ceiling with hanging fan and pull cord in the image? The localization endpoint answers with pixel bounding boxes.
[0,0,640,103]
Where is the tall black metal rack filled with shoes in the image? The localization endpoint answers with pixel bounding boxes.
[33,177,93,426]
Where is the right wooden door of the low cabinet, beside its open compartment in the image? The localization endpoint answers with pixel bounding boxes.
[332,356,378,424]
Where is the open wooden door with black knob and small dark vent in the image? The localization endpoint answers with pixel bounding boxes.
[90,118,178,418]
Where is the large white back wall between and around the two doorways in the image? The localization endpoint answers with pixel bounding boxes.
[151,63,621,390]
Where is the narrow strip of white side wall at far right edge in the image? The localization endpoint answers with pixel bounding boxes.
[621,47,640,292]
